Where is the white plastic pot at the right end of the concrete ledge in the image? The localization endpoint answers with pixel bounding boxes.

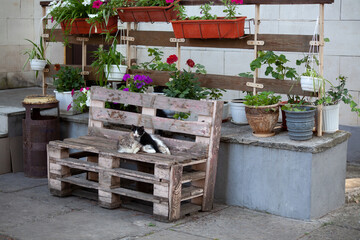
[322,104,340,133]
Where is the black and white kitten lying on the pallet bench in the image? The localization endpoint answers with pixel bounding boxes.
[131,125,171,155]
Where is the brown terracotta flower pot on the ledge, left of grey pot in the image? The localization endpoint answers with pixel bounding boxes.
[245,103,279,137]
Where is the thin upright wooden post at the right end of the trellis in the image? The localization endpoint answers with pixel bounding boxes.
[317,4,325,137]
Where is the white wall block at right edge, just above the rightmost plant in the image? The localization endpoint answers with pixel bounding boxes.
[340,55,360,91]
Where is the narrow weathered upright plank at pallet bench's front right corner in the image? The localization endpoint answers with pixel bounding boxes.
[169,165,183,221]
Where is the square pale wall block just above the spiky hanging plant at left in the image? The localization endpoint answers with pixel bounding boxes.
[7,18,34,45]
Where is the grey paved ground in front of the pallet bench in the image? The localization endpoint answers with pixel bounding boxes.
[0,173,360,240]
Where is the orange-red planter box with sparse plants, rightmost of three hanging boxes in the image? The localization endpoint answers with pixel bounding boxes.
[171,0,246,38]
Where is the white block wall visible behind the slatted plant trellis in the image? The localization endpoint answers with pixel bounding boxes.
[137,0,360,126]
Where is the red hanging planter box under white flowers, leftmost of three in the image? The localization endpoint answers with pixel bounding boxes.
[60,16,118,34]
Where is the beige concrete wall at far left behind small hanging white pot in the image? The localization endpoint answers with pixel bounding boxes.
[0,0,63,89]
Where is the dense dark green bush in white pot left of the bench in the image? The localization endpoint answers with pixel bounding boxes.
[54,66,85,92]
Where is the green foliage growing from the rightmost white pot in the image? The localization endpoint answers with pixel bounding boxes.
[316,75,360,116]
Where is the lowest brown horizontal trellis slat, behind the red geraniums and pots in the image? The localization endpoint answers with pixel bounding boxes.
[130,69,312,96]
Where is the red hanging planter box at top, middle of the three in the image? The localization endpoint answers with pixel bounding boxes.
[117,0,180,22]
